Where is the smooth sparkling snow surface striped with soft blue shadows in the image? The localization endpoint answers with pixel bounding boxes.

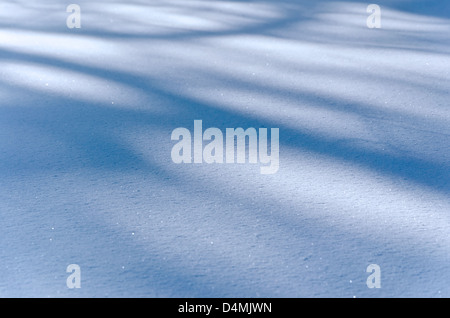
[0,0,450,297]
